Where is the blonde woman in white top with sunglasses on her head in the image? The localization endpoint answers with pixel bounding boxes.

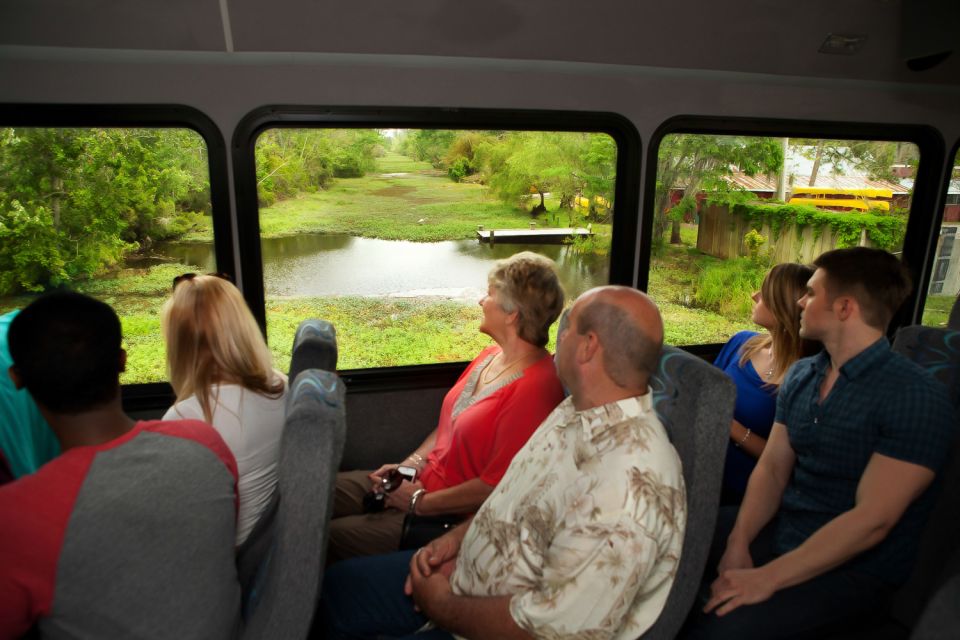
[161,274,287,546]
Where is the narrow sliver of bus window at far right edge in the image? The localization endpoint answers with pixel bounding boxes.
[923,151,960,327]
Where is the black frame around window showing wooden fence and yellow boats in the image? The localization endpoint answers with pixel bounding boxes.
[636,115,949,356]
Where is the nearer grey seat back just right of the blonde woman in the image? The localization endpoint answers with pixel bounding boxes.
[242,369,346,640]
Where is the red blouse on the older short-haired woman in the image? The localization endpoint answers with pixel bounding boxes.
[420,345,563,491]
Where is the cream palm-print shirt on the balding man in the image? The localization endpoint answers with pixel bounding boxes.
[451,389,687,640]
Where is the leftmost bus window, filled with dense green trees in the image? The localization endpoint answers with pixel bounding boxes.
[0,127,216,384]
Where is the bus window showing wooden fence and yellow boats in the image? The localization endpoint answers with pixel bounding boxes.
[647,133,919,345]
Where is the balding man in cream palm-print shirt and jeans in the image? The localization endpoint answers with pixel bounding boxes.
[318,287,686,640]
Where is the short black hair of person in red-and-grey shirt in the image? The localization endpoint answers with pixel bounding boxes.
[7,292,121,413]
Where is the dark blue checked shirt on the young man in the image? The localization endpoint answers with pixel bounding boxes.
[774,338,956,585]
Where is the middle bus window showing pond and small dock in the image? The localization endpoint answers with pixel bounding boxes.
[255,128,617,369]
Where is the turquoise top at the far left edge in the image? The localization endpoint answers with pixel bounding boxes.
[0,311,60,478]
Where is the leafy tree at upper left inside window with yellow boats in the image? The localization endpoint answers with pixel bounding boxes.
[653,133,783,244]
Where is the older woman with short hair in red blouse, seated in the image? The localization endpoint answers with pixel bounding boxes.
[327,251,563,564]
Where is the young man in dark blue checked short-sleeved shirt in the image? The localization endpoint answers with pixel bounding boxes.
[687,247,956,638]
